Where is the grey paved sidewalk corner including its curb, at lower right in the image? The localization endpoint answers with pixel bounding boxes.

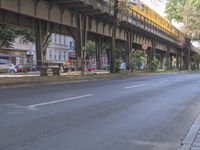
[178,114,200,150]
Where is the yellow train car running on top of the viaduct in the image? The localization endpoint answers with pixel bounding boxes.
[129,0,179,38]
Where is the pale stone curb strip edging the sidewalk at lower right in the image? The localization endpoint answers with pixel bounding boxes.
[178,114,200,150]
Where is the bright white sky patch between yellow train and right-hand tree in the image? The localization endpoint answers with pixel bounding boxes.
[141,0,166,17]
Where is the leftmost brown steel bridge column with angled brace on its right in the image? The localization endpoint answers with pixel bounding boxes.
[35,20,51,76]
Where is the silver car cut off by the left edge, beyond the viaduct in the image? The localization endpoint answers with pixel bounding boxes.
[0,59,17,73]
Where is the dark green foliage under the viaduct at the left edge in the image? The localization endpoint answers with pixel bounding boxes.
[0,25,35,48]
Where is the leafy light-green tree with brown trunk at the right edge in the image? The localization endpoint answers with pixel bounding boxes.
[166,0,200,70]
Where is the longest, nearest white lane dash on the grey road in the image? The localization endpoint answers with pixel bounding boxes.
[28,94,94,108]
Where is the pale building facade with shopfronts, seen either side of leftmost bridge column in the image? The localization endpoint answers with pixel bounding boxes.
[0,34,75,65]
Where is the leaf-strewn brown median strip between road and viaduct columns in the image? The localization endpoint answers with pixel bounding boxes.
[0,72,189,88]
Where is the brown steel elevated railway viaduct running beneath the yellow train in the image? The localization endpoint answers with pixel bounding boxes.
[0,0,194,67]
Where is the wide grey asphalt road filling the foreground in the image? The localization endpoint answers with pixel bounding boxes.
[0,73,200,150]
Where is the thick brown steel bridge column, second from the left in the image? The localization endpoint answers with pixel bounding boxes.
[74,14,88,70]
